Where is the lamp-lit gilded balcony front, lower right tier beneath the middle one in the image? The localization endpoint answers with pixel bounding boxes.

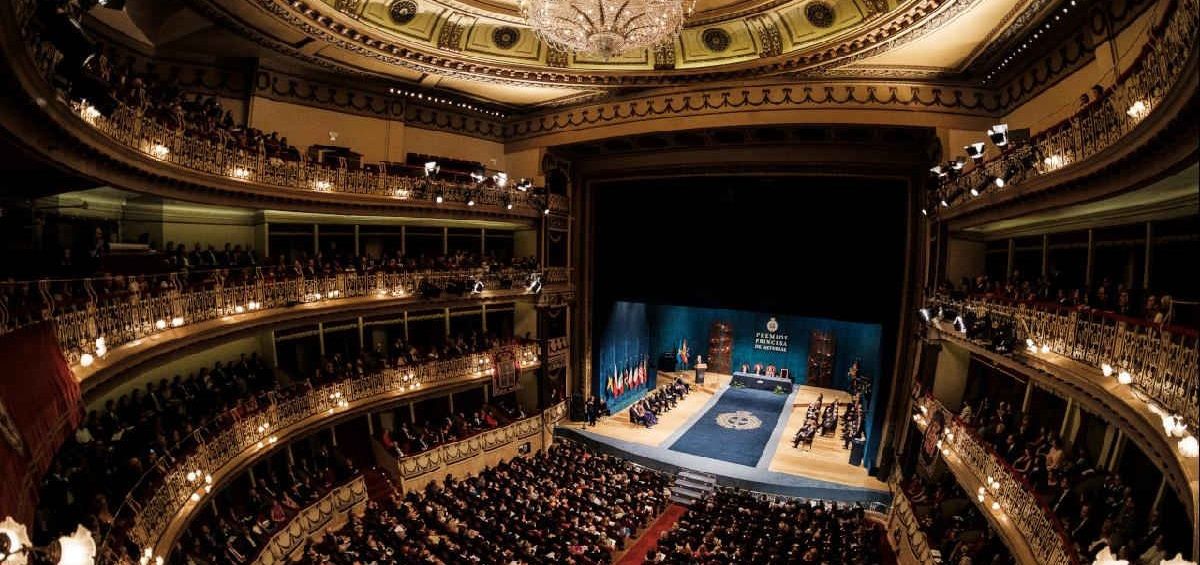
[913,398,1079,565]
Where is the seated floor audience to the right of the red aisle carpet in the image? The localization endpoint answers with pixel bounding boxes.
[643,488,884,565]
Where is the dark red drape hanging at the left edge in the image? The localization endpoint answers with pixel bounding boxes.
[0,323,83,524]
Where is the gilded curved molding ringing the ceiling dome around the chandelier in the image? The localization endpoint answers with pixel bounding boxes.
[193,0,974,89]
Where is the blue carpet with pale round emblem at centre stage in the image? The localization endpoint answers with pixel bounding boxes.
[670,389,788,467]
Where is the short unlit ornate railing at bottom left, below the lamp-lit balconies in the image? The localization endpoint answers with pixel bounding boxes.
[252,475,367,565]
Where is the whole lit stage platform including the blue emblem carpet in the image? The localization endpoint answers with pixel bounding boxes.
[558,372,890,501]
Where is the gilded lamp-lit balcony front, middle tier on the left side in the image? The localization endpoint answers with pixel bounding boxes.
[0,268,570,393]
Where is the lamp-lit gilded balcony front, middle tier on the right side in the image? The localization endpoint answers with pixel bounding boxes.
[926,291,1200,545]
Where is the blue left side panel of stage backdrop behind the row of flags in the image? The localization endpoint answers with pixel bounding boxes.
[594,302,655,414]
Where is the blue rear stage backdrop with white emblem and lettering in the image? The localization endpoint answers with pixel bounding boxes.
[649,306,882,465]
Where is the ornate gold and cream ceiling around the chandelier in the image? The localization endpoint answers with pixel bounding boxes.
[88,0,1051,107]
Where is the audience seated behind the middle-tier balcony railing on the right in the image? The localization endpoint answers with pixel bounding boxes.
[941,271,1180,326]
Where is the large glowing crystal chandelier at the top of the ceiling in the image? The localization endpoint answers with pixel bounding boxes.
[520,0,696,59]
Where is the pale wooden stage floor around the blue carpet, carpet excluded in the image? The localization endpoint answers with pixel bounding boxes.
[560,372,889,500]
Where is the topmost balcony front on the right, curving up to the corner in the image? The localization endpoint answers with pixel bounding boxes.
[934,0,1200,216]
